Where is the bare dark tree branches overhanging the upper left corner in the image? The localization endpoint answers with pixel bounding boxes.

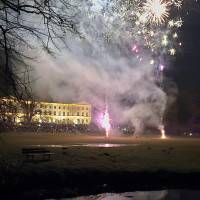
[0,0,78,96]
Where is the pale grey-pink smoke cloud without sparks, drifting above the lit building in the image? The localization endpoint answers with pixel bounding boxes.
[33,1,166,133]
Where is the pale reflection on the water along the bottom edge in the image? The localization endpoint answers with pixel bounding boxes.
[57,190,200,200]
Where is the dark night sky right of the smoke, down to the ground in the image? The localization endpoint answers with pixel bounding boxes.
[166,0,200,129]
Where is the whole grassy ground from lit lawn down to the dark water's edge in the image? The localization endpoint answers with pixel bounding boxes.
[0,133,200,200]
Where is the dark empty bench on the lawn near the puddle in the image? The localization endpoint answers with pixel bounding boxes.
[22,148,54,161]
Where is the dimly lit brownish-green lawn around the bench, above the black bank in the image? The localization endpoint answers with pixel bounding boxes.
[0,133,200,172]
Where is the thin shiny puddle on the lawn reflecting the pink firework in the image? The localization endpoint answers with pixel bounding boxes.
[31,143,138,148]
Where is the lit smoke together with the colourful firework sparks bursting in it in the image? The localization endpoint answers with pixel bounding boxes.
[30,0,188,133]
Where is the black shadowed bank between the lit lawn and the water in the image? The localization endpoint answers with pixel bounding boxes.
[1,169,200,200]
